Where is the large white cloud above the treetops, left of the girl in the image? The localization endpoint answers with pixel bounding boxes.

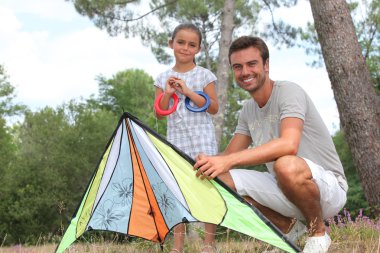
[0,1,167,109]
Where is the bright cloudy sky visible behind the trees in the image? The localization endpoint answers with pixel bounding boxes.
[0,0,339,134]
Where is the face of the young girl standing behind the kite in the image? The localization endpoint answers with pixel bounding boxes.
[169,29,201,63]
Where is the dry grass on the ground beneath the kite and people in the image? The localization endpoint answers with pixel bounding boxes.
[0,210,380,253]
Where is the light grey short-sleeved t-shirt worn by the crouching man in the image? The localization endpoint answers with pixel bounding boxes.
[235,81,348,191]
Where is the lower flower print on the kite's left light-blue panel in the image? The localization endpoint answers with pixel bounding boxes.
[95,199,125,231]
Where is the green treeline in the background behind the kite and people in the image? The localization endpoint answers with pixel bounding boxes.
[0,65,367,245]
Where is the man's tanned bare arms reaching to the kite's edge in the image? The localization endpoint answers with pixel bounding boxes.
[194,118,303,179]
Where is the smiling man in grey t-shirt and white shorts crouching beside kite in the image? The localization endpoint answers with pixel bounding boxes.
[194,36,348,253]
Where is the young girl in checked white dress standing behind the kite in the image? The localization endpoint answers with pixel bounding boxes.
[154,24,218,253]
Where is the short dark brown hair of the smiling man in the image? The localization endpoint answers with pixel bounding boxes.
[228,36,269,63]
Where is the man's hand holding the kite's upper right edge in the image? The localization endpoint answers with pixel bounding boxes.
[194,154,230,180]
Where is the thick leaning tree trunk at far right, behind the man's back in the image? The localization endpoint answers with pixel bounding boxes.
[310,0,380,206]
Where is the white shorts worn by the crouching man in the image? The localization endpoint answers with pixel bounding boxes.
[230,158,347,220]
